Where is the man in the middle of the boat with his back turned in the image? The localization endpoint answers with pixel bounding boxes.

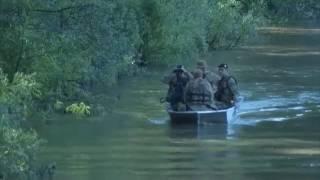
[184,69,215,111]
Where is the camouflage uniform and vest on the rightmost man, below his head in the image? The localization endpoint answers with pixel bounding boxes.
[214,76,240,109]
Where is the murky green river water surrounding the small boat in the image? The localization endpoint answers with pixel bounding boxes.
[39,26,320,180]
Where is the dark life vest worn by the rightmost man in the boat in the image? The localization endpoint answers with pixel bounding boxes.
[214,76,238,103]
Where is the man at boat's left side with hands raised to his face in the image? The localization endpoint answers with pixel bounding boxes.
[162,65,193,111]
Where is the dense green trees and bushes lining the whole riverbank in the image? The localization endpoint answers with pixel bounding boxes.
[0,0,320,179]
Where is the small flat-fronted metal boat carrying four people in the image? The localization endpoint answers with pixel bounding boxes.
[168,107,236,124]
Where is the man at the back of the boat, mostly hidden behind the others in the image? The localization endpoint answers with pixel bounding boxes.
[197,61,221,92]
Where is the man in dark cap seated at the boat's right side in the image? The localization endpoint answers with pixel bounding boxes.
[214,64,240,109]
